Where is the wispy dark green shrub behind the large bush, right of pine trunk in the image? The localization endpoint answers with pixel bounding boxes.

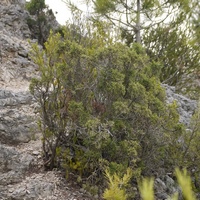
[144,26,200,88]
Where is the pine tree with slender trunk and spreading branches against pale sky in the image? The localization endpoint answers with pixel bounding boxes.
[90,0,191,45]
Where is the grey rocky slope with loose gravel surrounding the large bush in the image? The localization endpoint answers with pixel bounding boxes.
[0,0,196,200]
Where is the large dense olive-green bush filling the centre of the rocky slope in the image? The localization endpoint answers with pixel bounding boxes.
[30,23,194,197]
